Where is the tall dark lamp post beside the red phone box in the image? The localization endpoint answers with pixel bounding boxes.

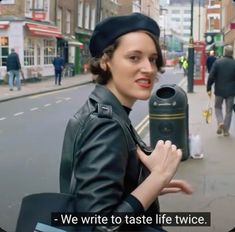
[188,0,194,93]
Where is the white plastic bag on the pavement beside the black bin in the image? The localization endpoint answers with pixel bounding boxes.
[189,134,204,159]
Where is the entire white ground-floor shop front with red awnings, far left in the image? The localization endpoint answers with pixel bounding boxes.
[0,20,62,80]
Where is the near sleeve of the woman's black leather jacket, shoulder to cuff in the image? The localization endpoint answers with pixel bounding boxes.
[74,116,143,231]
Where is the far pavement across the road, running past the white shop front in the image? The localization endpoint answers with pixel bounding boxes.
[0,74,92,102]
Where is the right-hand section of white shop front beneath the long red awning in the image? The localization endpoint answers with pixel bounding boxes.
[23,22,62,78]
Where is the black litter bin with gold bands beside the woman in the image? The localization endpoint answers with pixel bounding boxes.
[149,84,189,160]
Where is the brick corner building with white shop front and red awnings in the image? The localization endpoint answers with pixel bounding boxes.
[0,0,79,79]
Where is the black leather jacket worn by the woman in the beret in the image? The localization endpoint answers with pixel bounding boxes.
[60,85,159,231]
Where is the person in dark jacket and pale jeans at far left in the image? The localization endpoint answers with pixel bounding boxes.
[6,48,21,91]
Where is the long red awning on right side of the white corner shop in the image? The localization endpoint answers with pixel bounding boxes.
[25,23,62,38]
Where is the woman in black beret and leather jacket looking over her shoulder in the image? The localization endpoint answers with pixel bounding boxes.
[60,13,192,232]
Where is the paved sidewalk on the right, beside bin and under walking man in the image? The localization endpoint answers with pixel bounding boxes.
[152,86,235,232]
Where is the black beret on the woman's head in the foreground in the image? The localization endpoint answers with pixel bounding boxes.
[89,13,160,57]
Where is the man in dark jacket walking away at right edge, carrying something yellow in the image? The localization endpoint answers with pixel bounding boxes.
[207,45,235,136]
